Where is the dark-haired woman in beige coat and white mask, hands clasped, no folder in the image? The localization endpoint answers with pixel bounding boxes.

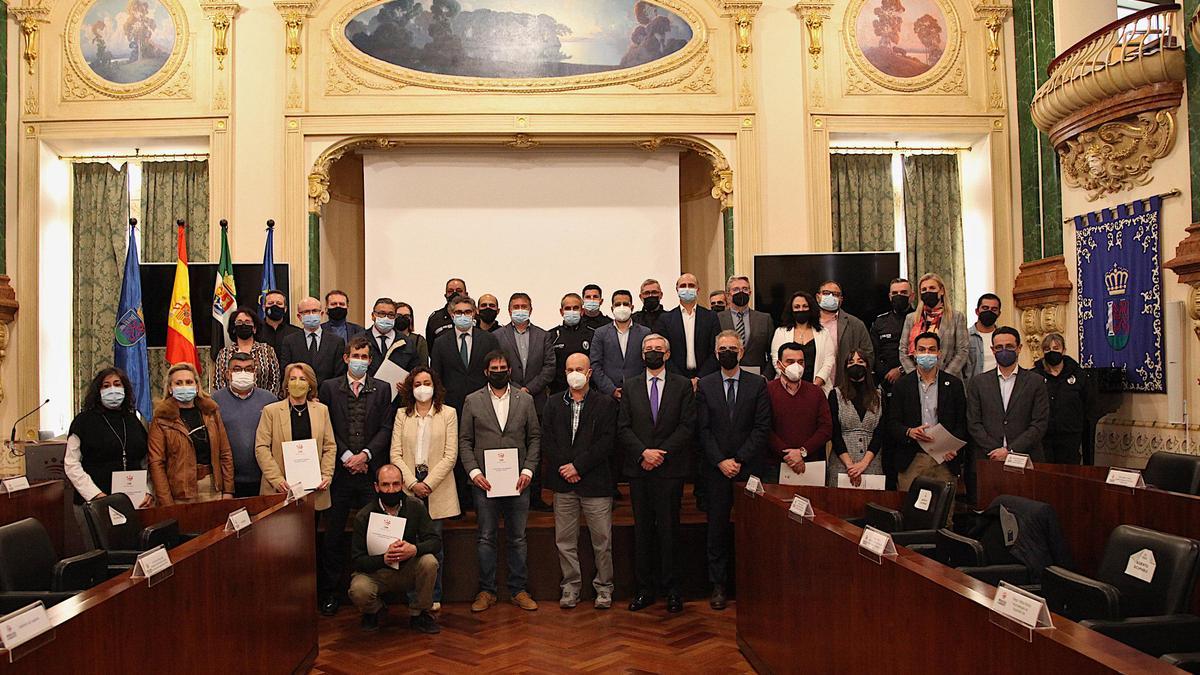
[391,366,462,609]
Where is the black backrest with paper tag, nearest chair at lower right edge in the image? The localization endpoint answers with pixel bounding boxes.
[1096,525,1200,617]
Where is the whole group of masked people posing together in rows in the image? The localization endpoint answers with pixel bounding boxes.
[66,274,1094,633]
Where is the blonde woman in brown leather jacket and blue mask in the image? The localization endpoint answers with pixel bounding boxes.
[148,363,234,506]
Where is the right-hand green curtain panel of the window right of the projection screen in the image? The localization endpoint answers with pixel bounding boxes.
[904,155,966,309]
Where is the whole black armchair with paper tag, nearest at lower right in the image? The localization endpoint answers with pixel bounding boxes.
[1042,525,1200,656]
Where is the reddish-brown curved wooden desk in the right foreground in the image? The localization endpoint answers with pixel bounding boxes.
[734,485,1180,675]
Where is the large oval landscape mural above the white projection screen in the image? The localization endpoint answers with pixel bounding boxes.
[346,0,692,79]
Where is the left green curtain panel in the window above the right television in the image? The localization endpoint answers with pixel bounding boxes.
[829,154,895,251]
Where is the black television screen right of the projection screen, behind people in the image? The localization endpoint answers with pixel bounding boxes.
[754,251,900,328]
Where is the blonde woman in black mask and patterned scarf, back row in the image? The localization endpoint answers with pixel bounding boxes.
[900,273,971,380]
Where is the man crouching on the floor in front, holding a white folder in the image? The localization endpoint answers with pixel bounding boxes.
[350,464,442,634]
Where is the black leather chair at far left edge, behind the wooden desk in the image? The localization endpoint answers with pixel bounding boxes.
[0,518,108,614]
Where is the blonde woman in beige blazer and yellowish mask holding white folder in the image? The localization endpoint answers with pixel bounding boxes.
[254,363,337,510]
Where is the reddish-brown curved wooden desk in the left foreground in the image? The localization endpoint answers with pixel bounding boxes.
[0,498,317,674]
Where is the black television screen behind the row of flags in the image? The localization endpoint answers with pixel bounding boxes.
[140,263,290,347]
